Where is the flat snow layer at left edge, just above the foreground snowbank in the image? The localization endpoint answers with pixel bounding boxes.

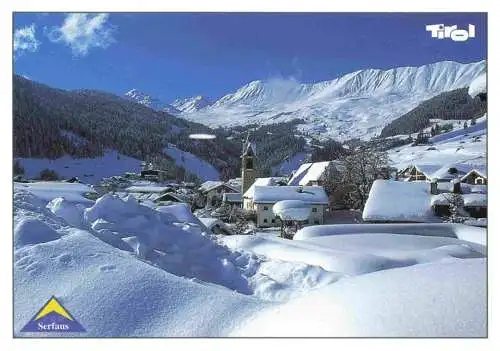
[14,181,95,203]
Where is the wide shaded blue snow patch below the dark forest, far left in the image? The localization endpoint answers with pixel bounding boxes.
[16,150,141,184]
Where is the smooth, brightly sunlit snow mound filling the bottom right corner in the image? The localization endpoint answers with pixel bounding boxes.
[231,259,487,338]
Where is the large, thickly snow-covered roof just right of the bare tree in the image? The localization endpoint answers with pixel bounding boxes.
[363,179,436,222]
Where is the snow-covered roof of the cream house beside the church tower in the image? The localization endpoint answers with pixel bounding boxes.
[253,186,328,205]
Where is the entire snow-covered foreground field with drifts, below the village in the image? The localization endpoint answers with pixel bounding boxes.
[14,183,486,337]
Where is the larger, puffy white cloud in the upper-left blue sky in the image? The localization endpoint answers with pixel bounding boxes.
[48,13,115,56]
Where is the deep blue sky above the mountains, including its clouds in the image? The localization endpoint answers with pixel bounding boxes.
[13,13,486,102]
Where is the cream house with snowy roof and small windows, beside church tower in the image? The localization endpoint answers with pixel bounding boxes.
[243,185,328,227]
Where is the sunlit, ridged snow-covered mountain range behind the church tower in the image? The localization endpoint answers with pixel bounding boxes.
[182,61,486,140]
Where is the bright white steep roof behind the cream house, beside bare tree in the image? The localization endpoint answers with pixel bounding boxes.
[288,160,344,186]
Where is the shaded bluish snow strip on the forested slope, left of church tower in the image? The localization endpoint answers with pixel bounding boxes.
[163,145,220,180]
